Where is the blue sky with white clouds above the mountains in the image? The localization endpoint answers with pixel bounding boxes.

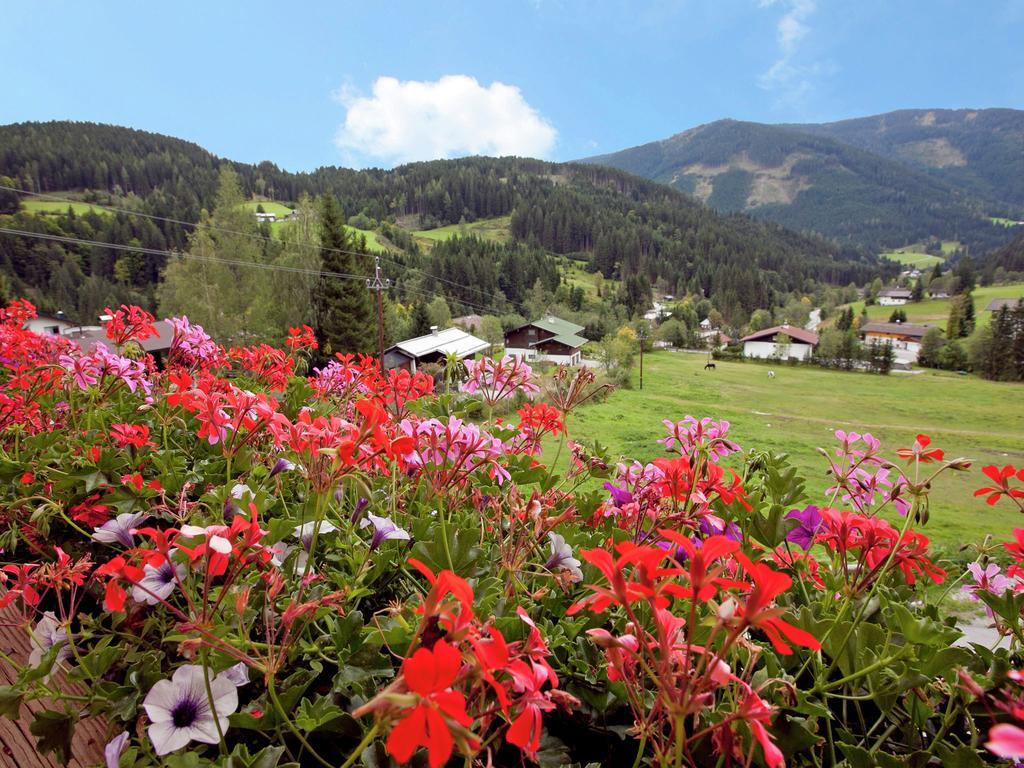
[0,0,1024,170]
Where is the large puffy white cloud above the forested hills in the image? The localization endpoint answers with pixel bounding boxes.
[335,75,558,163]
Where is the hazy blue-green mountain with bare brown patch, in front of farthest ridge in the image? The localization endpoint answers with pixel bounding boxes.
[584,120,1007,252]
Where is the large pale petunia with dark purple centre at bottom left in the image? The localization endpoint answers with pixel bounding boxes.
[142,665,239,755]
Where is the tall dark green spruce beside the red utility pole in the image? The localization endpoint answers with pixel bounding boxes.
[313,194,377,356]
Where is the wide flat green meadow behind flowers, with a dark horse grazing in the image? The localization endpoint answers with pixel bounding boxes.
[549,351,1024,548]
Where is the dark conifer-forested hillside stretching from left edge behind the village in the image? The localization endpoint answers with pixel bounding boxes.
[0,122,879,327]
